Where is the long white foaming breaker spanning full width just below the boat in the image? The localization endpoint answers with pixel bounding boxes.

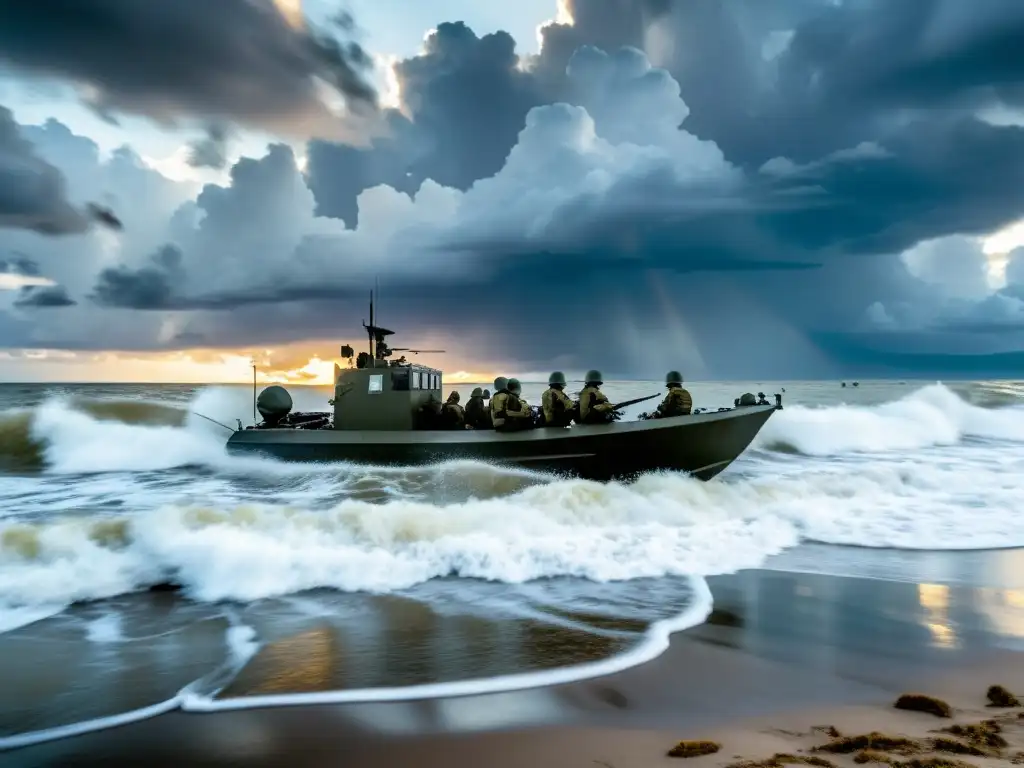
[6,421,1024,638]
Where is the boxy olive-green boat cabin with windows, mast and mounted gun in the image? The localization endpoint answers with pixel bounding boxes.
[332,296,443,430]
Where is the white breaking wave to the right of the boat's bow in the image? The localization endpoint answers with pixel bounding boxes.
[755,384,1024,457]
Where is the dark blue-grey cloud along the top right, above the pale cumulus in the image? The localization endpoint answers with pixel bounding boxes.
[309,0,1024,219]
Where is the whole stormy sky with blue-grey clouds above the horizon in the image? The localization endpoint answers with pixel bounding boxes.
[0,0,1024,379]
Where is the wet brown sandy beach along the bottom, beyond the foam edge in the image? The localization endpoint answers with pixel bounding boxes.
[12,571,1024,768]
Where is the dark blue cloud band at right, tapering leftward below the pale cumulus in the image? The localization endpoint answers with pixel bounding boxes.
[441,119,1024,280]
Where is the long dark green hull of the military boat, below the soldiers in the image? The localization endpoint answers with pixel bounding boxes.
[227,406,777,481]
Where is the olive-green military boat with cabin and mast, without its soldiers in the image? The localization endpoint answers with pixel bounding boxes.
[227,296,782,481]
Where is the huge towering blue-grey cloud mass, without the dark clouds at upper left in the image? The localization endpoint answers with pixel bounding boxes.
[0,0,1024,377]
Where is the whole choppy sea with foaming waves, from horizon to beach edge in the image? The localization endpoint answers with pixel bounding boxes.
[0,381,1024,748]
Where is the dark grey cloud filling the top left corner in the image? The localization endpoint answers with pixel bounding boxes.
[0,0,376,134]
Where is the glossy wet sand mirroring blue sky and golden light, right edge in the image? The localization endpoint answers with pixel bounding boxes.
[686,570,1024,682]
